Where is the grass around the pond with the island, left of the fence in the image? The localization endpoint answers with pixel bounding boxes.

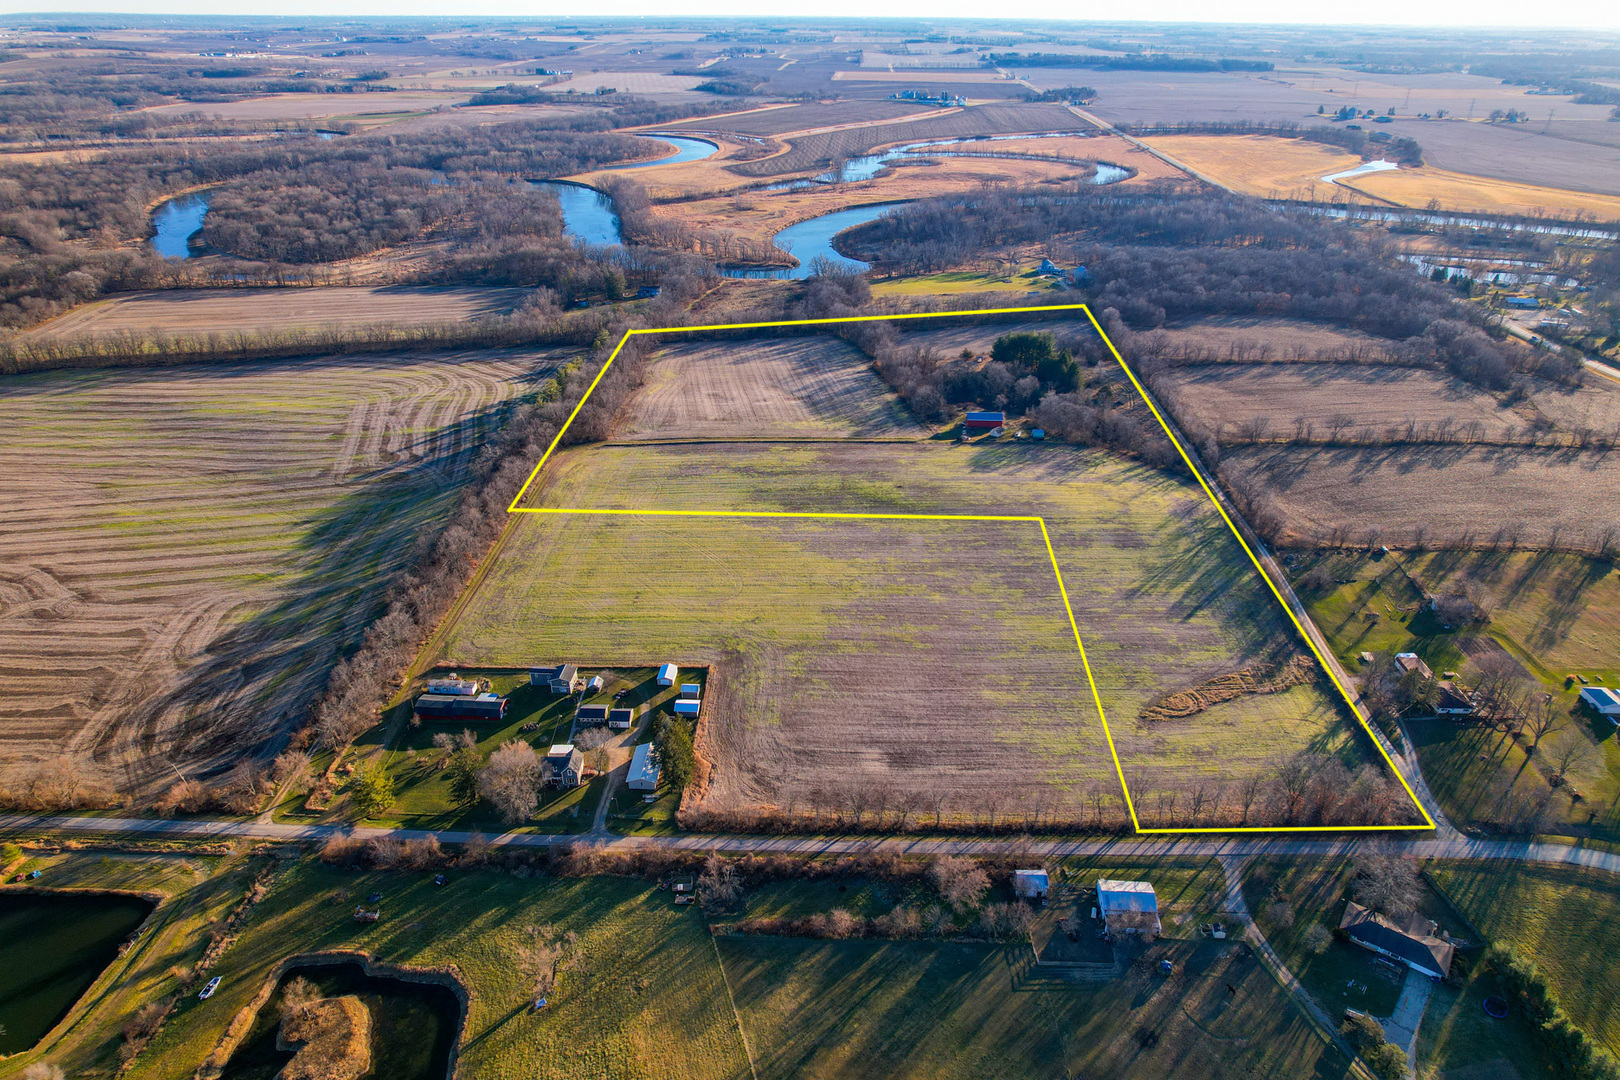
[130,861,748,1080]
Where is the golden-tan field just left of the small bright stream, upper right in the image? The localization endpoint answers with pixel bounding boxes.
[1144,134,1361,201]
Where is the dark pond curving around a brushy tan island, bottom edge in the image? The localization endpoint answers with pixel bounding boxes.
[220,963,462,1080]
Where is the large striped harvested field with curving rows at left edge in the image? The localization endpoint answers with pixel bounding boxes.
[0,351,548,789]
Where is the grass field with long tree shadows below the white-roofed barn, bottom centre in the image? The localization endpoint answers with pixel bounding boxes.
[716,936,1349,1080]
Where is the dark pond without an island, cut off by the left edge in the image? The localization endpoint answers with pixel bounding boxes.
[0,892,152,1054]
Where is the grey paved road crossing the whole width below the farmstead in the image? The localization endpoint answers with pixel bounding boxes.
[9,814,1620,874]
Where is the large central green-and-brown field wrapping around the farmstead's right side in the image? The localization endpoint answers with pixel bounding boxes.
[444,442,1393,824]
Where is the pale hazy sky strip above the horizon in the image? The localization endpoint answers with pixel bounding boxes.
[0,0,1620,31]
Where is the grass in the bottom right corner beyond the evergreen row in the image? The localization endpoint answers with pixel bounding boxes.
[1430,863,1620,1054]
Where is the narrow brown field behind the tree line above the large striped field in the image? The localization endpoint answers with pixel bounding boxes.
[32,285,528,337]
